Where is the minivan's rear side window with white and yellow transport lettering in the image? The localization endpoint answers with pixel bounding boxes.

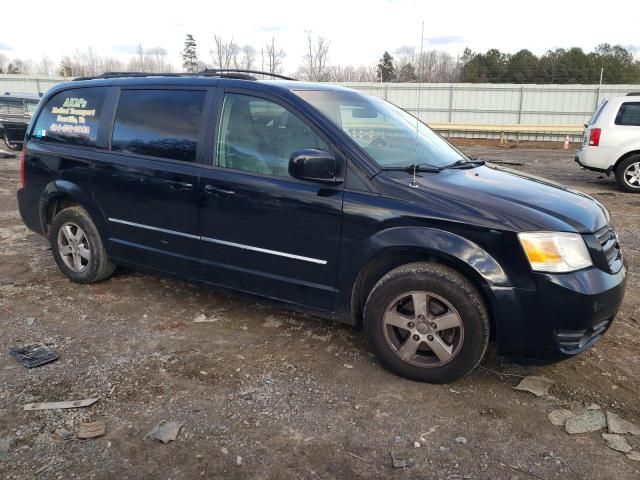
[33,88,105,146]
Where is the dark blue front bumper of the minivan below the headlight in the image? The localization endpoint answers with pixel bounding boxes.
[493,265,627,362]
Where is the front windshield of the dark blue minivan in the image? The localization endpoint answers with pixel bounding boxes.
[294,90,467,168]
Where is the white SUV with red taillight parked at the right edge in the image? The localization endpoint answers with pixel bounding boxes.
[576,93,640,193]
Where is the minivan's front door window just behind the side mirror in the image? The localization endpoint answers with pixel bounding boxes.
[217,93,329,177]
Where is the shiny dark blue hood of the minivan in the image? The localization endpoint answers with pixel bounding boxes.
[385,164,607,233]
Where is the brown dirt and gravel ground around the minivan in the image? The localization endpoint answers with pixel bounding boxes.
[0,145,640,479]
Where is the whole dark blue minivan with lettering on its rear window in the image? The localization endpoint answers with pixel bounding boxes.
[18,71,627,382]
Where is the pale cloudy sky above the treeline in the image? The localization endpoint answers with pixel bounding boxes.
[0,0,640,73]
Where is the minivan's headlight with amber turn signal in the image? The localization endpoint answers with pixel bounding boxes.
[518,232,593,273]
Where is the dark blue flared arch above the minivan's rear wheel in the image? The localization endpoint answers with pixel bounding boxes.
[38,179,109,238]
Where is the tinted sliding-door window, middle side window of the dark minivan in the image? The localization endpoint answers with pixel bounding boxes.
[111,90,205,162]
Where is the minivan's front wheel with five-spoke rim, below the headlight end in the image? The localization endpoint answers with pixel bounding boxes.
[364,263,489,383]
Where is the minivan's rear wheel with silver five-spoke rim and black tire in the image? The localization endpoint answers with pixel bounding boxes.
[49,207,116,283]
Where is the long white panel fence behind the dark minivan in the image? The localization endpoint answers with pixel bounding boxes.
[5,74,640,140]
